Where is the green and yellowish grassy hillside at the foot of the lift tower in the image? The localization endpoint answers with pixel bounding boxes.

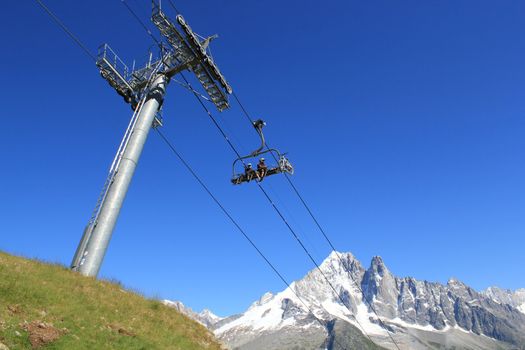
[0,253,220,350]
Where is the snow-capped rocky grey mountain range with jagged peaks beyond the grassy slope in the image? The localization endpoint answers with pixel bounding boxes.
[171,252,525,350]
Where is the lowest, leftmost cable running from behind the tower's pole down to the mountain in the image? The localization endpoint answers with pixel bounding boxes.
[155,128,352,349]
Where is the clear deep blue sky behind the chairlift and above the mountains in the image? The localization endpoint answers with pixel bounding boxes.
[0,0,525,315]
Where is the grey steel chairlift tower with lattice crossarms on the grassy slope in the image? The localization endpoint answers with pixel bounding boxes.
[71,1,232,277]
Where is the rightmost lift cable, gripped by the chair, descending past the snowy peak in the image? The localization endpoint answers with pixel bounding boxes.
[232,91,399,350]
